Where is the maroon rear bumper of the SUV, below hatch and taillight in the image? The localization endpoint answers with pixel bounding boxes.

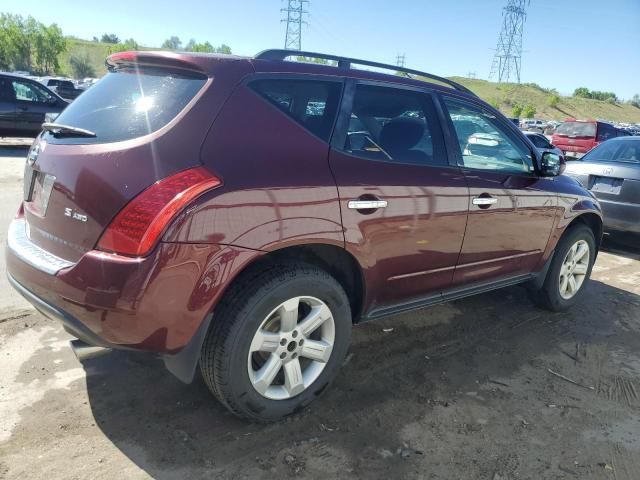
[6,220,262,354]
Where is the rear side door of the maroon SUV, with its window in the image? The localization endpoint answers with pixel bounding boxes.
[330,82,468,310]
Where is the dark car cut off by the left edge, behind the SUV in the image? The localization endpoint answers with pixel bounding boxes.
[0,73,69,136]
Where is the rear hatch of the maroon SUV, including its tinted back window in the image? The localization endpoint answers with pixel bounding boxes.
[24,52,250,262]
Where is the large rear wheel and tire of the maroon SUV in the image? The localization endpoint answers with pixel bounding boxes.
[200,263,352,422]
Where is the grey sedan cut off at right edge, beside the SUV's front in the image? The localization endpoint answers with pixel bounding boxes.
[565,137,640,233]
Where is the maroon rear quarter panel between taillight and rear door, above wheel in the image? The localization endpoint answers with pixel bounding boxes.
[165,81,344,251]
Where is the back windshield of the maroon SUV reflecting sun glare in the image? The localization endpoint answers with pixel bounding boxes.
[47,68,207,144]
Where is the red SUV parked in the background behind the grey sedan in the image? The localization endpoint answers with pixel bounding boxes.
[552,120,627,159]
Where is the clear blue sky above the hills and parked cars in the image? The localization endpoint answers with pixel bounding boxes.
[5,0,640,99]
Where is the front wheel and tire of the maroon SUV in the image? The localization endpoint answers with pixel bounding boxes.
[534,225,597,312]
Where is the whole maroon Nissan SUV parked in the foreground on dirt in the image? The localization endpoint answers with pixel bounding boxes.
[7,50,602,420]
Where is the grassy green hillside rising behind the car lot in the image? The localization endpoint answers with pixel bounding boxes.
[60,37,640,123]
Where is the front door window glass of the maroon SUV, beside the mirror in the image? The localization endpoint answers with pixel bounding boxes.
[444,98,532,173]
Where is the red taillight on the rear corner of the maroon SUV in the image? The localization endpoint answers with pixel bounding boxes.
[98,167,222,256]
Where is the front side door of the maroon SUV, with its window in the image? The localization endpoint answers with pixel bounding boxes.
[444,95,557,286]
